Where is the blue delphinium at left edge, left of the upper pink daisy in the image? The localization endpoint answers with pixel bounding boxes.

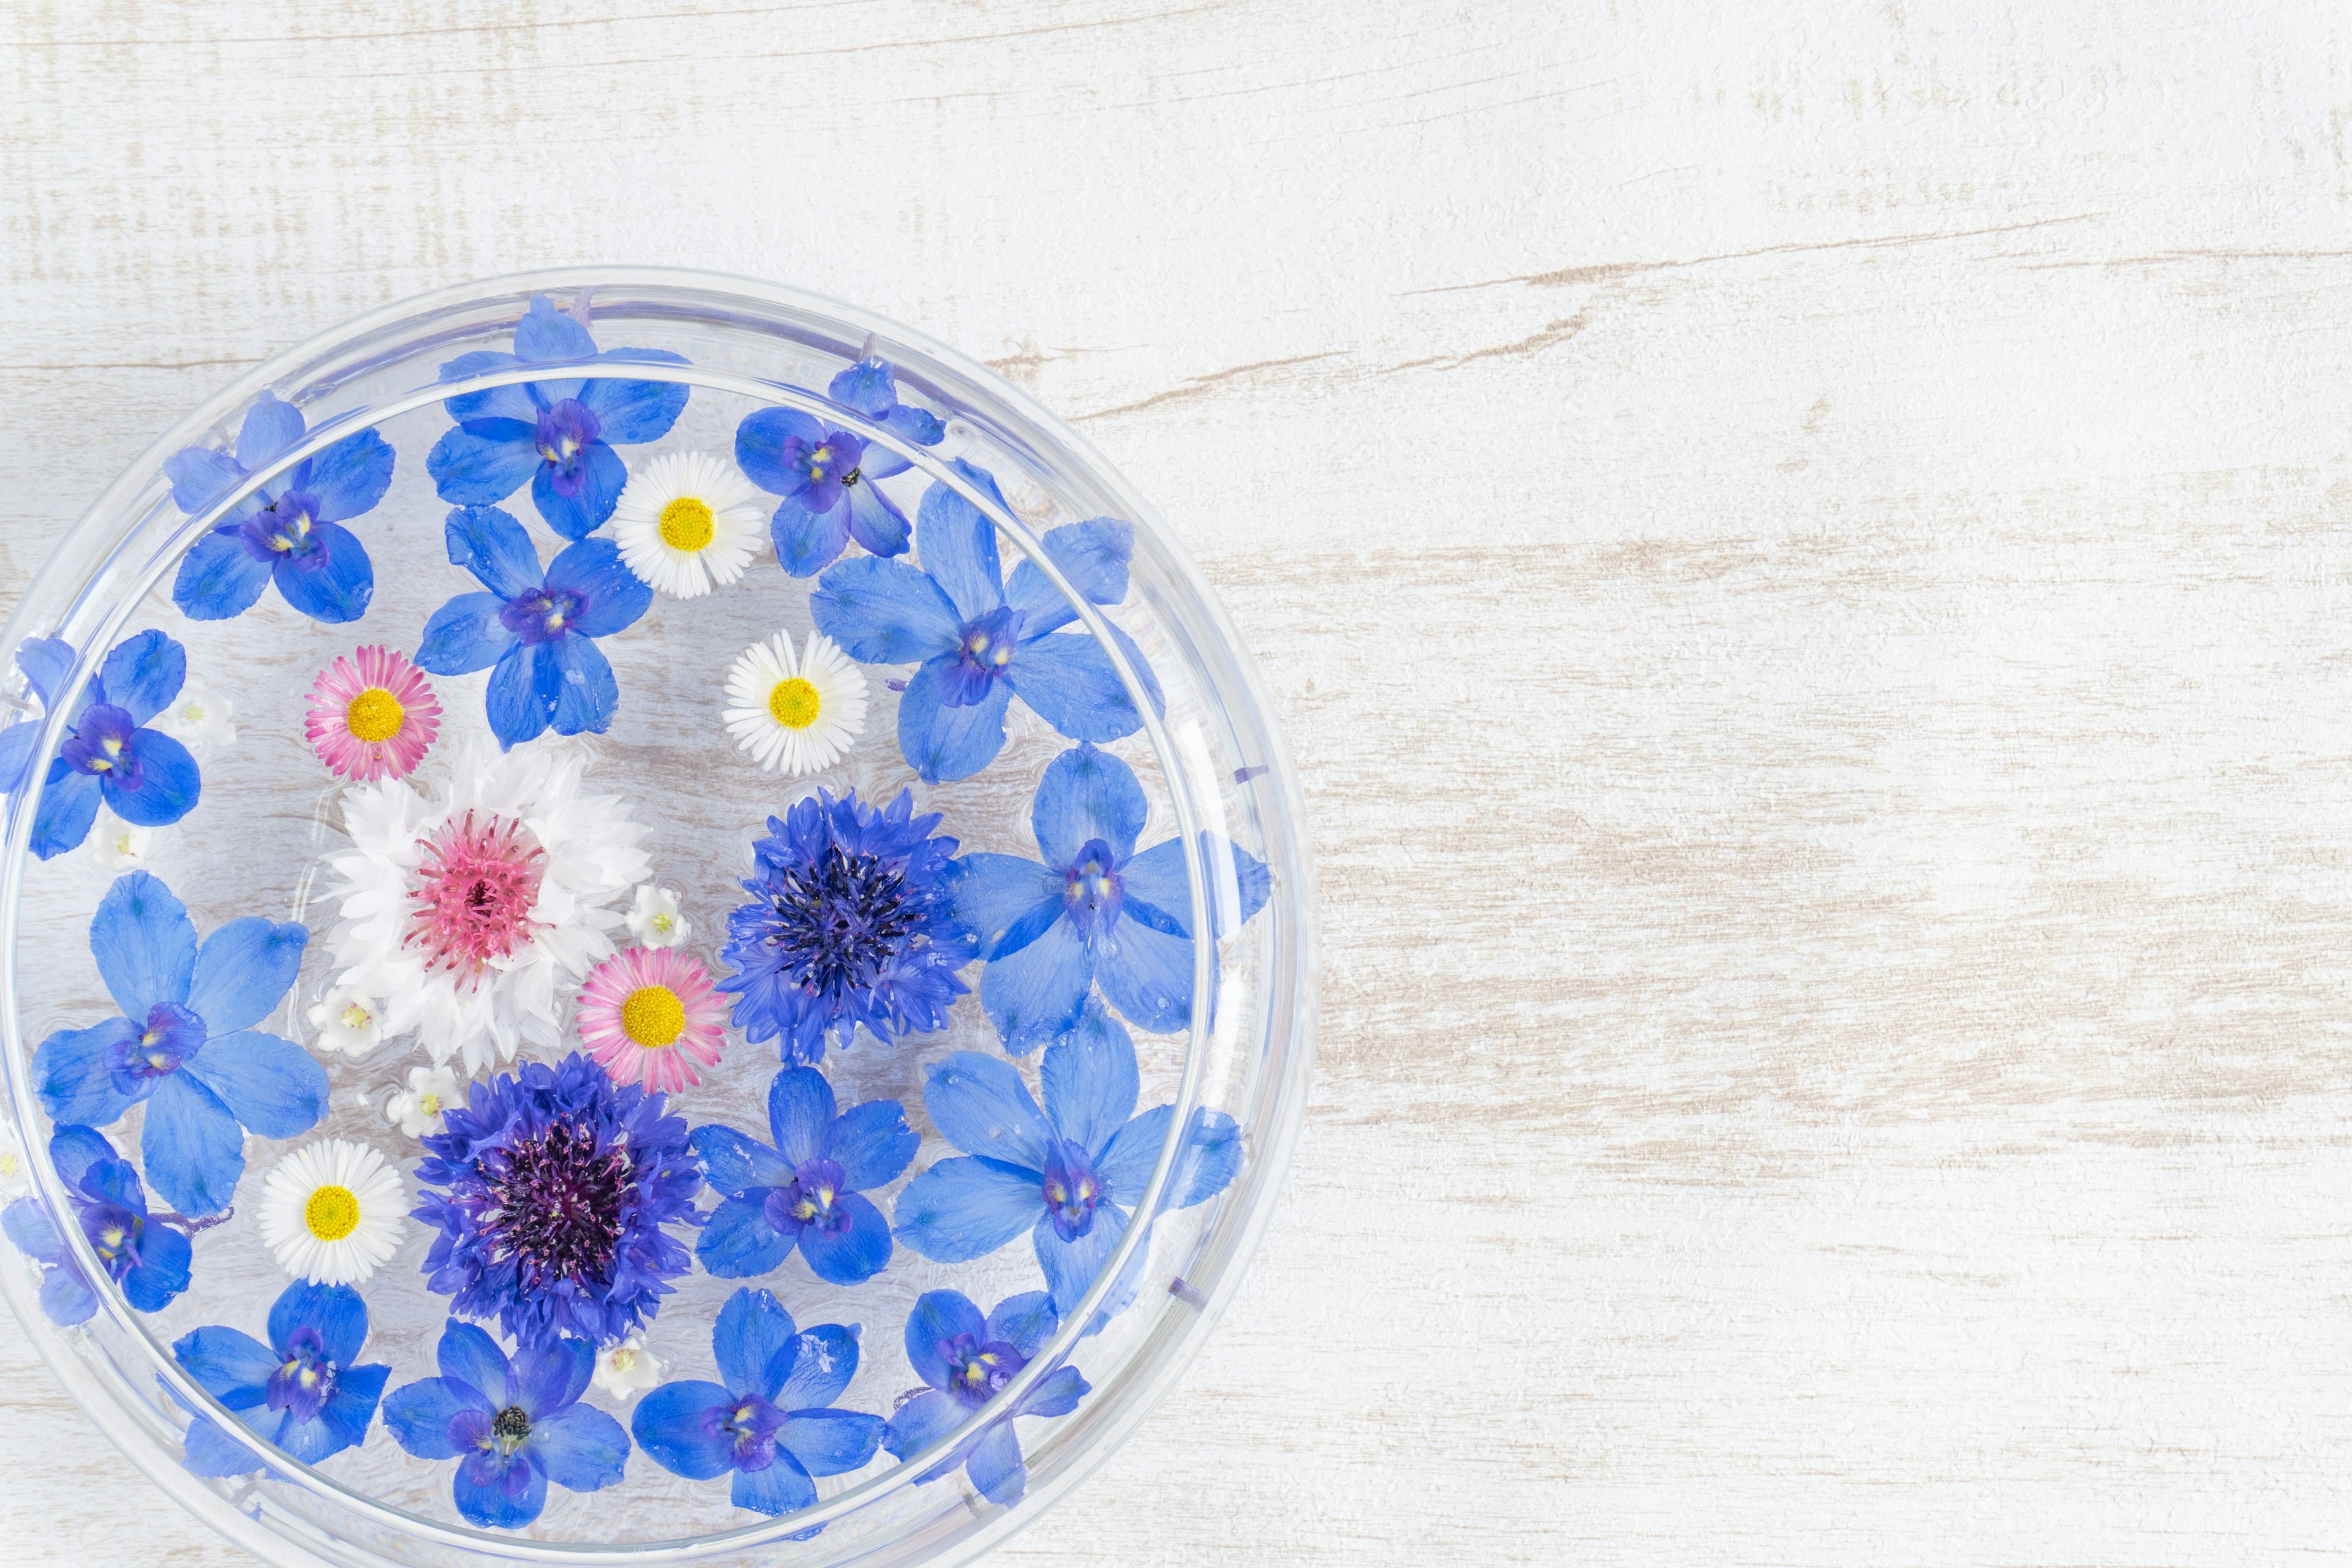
[0,632,205,861]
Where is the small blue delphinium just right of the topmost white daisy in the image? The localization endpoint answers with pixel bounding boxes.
[736,357,948,576]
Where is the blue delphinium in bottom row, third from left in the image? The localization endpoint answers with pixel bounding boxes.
[628,1286,882,1514]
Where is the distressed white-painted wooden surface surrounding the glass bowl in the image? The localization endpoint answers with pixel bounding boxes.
[0,0,2352,1568]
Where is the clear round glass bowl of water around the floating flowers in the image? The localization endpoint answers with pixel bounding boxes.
[0,268,1317,1566]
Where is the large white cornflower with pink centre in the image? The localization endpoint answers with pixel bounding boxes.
[327,748,647,1072]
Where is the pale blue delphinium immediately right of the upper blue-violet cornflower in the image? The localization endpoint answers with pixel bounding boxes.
[948,745,1268,1055]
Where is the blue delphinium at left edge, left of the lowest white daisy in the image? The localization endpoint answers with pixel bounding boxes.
[0,1126,190,1329]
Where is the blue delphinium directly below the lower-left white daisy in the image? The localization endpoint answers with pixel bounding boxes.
[172,1279,393,1476]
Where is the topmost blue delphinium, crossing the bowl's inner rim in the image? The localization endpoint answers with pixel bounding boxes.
[426,294,687,538]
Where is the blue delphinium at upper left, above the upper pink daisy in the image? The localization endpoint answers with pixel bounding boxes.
[162,393,393,625]
